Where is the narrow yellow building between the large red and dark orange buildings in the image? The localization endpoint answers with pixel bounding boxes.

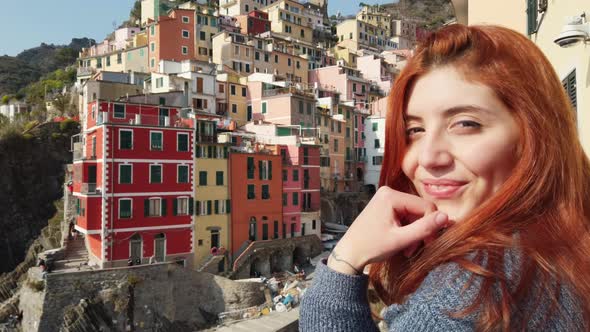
[193,119,231,273]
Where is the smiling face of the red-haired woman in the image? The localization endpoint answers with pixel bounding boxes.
[402,66,519,221]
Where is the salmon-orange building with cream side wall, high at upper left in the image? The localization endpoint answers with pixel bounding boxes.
[147,9,195,72]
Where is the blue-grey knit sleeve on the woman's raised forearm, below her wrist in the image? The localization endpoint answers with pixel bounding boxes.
[299,262,379,332]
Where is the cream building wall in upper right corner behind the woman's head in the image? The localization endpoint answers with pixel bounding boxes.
[453,0,590,155]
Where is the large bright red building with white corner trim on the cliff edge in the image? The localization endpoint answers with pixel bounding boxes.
[73,101,194,268]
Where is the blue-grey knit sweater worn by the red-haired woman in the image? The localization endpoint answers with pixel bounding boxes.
[299,255,585,332]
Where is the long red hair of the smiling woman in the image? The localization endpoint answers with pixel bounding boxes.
[370,24,590,330]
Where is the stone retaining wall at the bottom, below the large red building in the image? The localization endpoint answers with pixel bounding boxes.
[21,263,265,331]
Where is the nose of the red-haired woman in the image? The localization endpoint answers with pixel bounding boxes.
[418,134,453,169]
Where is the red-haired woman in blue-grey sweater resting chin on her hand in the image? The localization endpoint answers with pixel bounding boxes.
[300,25,590,331]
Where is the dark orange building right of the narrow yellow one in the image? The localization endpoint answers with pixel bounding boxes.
[229,152,283,259]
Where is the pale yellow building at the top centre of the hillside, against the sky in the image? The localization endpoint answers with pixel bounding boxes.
[262,0,313,43]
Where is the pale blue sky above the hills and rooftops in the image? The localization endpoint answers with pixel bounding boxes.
[0,0,392,56]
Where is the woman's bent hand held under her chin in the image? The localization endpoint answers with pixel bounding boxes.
[328,186,448,274]
